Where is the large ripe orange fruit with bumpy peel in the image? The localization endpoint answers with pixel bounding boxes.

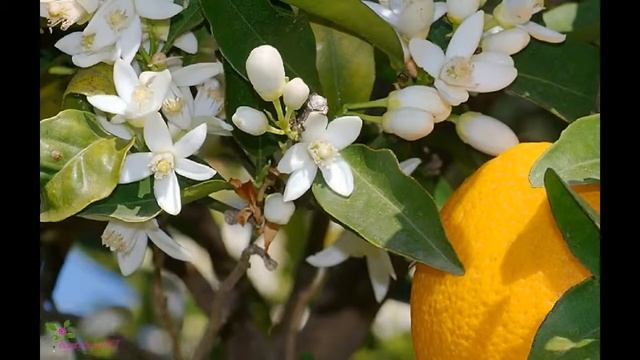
[411,143,600,360]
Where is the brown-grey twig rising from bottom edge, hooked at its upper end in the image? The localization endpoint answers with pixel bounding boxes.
[193,244,278,360]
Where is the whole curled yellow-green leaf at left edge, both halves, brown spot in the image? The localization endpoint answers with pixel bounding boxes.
[40,110,133,222]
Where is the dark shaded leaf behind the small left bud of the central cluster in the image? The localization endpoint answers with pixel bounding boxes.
[223,61,279,169]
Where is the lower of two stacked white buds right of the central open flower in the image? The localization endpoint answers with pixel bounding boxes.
[382,107,434,141]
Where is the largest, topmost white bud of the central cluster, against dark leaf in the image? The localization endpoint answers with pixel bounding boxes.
[246,45,286,101]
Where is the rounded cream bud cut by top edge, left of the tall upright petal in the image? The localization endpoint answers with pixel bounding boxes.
[396,0,433,38]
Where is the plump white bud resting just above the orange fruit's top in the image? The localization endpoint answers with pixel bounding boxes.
[456,111,519,156]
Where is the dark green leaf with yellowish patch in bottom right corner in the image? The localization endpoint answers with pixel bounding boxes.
[529,278,600,360]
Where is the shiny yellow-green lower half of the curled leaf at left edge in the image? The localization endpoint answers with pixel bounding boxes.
[40,138,133,222]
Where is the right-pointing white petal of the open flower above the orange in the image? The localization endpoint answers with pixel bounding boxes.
[469,61,518,93]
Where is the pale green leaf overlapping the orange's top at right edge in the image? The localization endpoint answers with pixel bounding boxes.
[529,114,600,187]
